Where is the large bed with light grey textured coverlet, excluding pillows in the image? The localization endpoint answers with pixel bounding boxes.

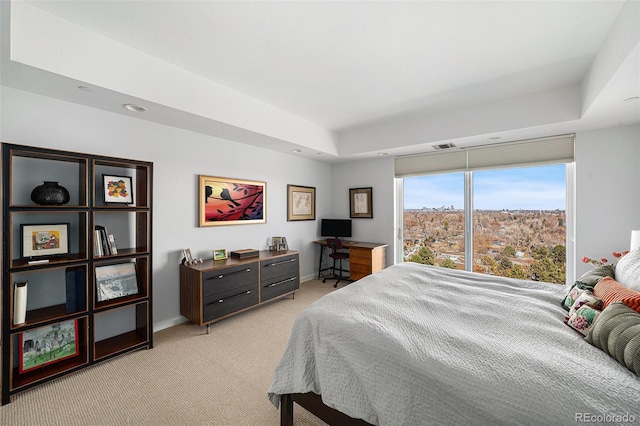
[268,263,640,425]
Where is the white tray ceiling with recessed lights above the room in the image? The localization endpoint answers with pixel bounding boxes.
[2,0,640,162]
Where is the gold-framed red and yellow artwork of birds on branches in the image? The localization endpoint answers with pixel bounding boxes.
[198,175,267,226]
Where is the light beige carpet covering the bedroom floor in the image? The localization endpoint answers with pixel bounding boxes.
[0,280,334,426]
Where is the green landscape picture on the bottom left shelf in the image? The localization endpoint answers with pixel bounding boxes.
[18,319,80,374]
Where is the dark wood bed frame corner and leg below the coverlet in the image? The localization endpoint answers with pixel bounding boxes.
[280,392,372,426]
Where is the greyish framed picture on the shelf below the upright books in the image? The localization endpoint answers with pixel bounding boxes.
[96,262,138,302]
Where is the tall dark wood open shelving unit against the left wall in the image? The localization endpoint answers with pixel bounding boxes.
[2,143,153,404]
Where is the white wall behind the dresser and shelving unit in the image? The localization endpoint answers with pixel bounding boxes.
[0,87,332,330]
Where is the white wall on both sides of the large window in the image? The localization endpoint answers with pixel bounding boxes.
[331,125,640,282]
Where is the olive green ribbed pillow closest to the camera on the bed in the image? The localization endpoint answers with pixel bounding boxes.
[586,302,640,376]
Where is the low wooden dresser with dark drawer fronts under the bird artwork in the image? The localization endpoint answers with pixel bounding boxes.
[180,250,300,333]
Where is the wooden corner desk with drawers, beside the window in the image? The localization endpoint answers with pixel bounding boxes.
[314,240,388,281]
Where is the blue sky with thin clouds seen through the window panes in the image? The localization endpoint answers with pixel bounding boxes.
[404,164,566,210]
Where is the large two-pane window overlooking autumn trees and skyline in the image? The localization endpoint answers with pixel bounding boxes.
[396,135,575,284]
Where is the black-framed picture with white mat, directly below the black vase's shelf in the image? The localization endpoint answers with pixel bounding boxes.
[20,223,69,258]
